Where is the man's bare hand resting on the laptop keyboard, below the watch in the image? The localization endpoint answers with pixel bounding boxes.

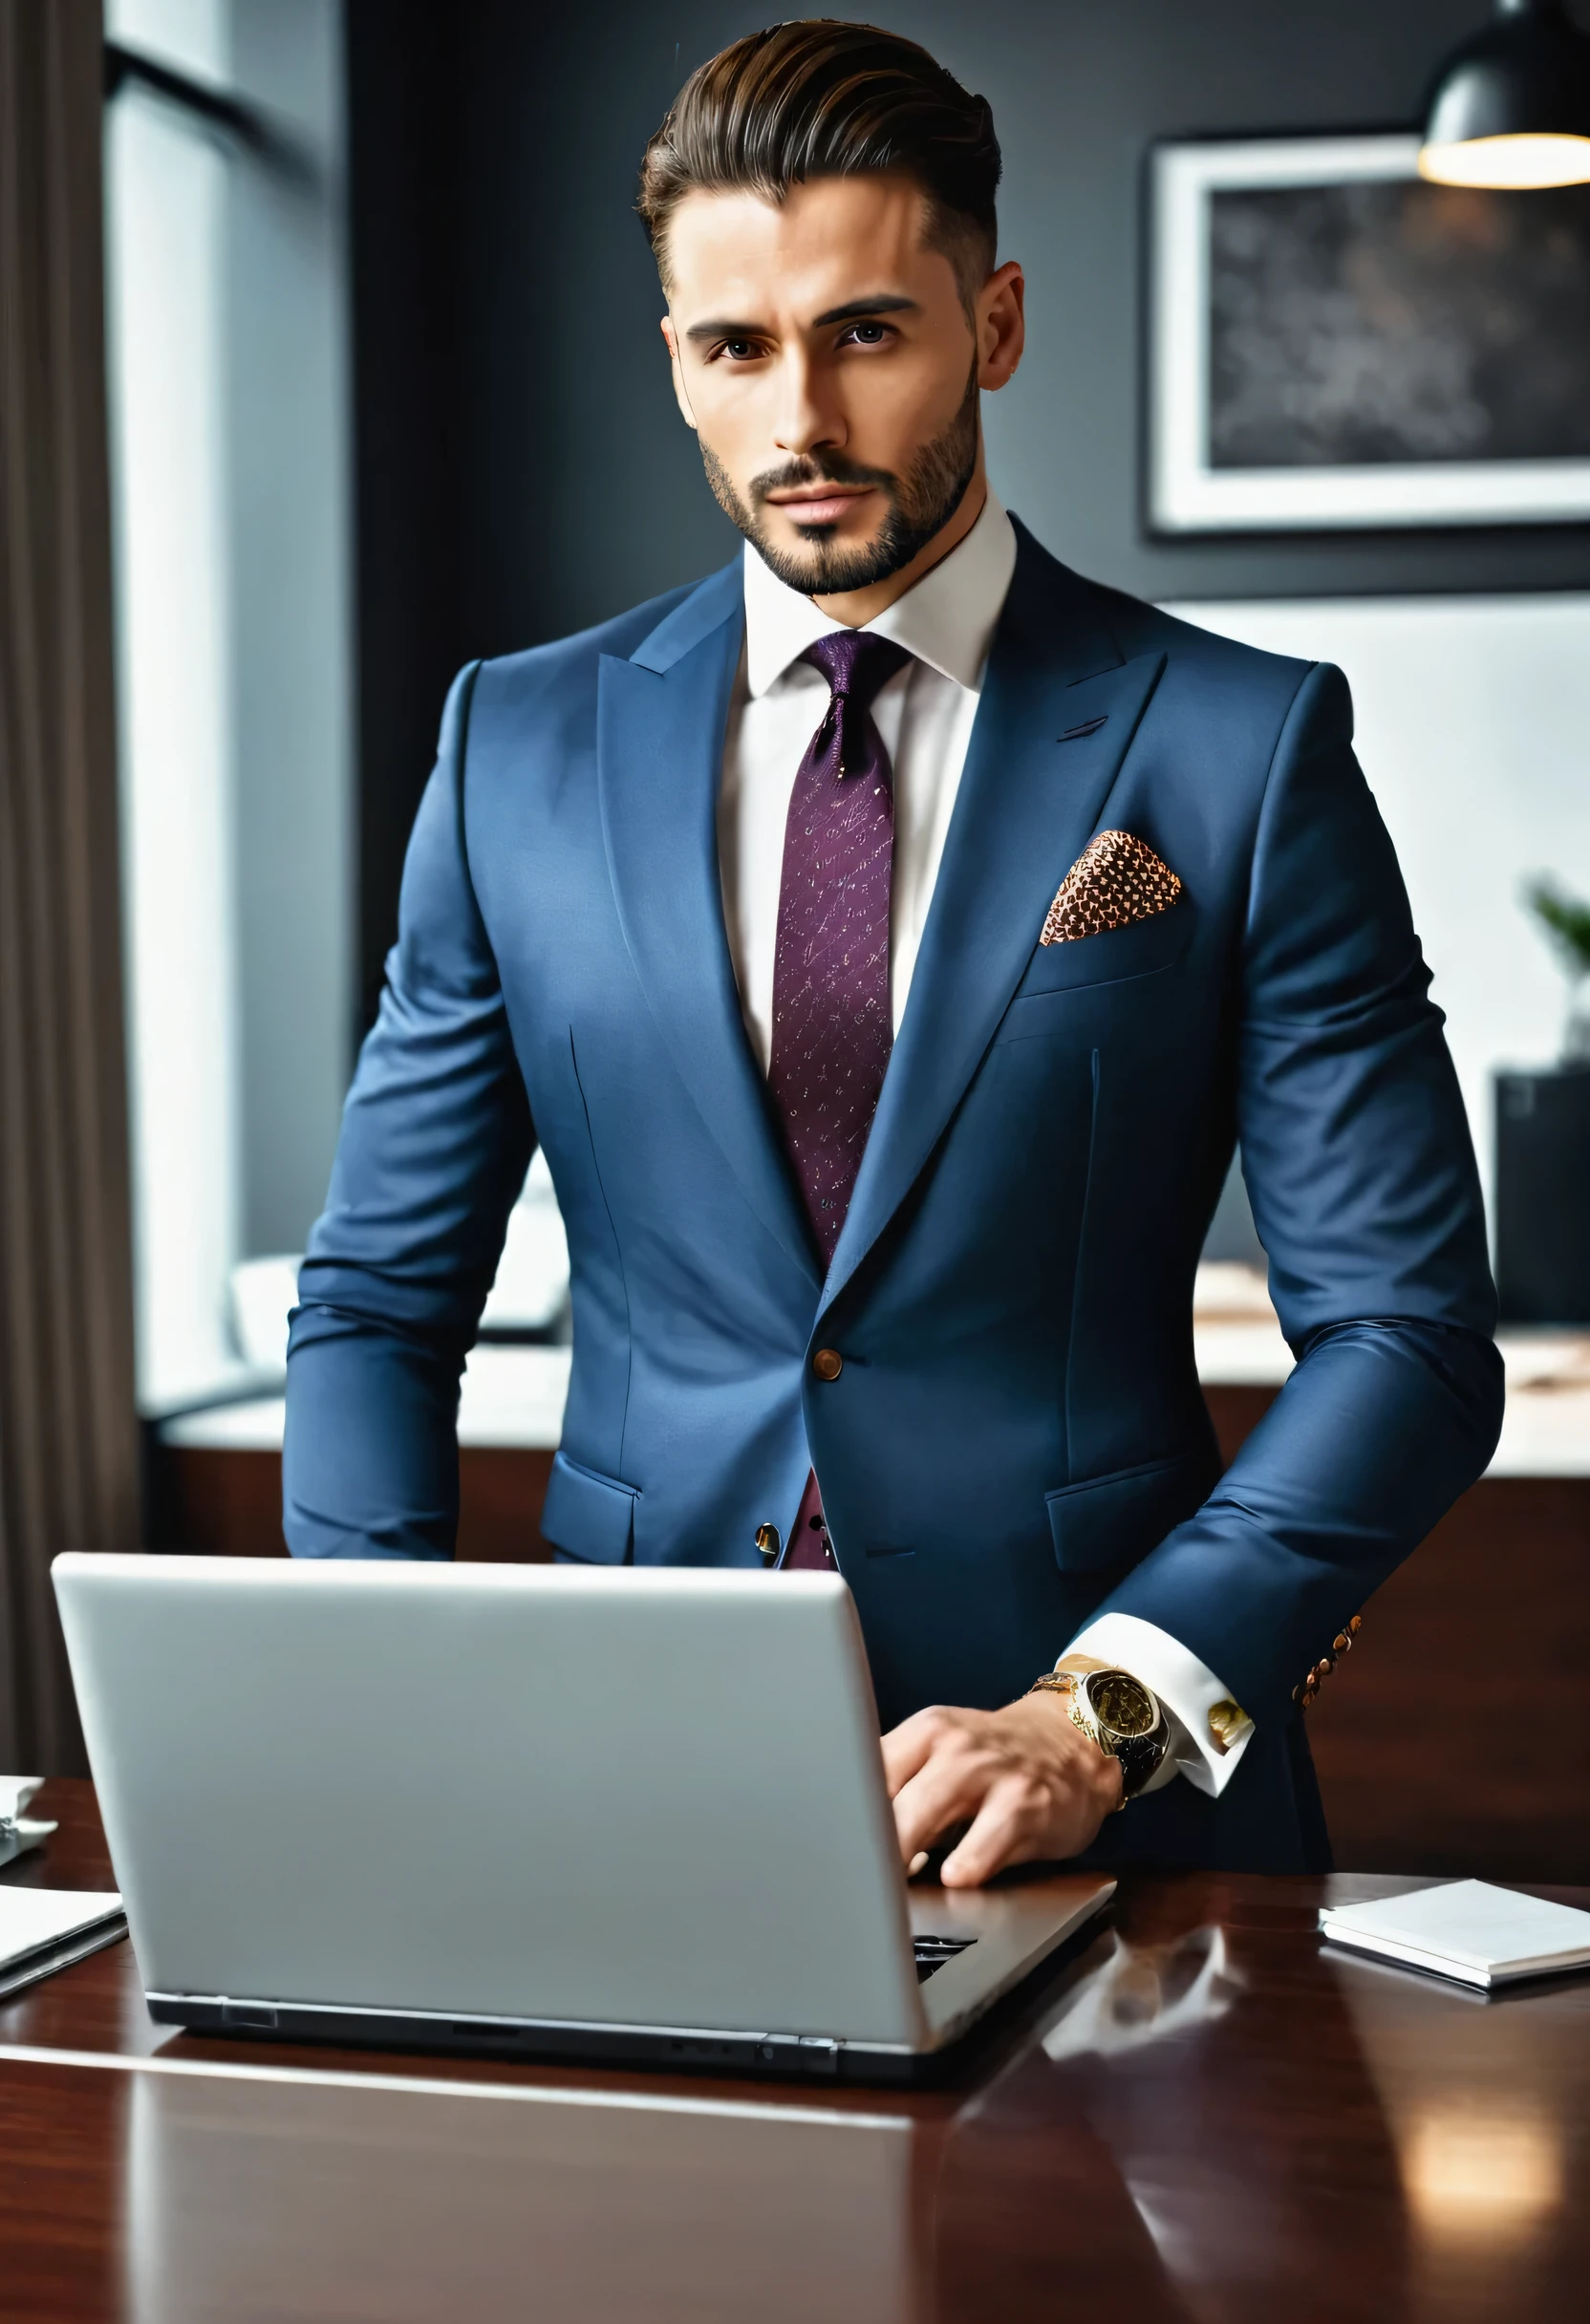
[883,1694,1121,1887]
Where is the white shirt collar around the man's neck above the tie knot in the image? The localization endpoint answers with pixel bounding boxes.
[743,493,1016,698]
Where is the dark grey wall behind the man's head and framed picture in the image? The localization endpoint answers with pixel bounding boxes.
[349,0,1590,1006]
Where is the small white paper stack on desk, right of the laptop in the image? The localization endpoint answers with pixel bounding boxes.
[1321,1880,1590,1991]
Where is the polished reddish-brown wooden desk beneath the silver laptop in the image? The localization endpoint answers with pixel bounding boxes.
[0,1782,1590,2324]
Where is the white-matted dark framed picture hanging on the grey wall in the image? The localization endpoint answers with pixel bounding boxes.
[1146,137,1590,534]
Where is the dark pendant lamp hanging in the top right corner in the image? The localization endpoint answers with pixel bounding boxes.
[1418,0,1590,188]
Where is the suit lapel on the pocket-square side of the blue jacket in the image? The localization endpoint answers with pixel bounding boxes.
[823,527,1165,1306]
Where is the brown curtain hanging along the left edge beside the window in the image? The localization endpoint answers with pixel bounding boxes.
[0,0,140,1775]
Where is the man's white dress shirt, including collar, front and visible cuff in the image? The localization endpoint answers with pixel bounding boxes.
[719,493,1251,1795]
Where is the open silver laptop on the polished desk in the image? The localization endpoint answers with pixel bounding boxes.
[54,1555,1113,2080]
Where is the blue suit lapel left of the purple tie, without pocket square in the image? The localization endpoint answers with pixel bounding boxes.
[597,560,821,1287]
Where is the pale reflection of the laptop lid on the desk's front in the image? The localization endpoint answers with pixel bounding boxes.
[125,2076,925,2324]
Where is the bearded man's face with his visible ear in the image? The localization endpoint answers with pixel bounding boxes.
[662,177,1021,597]
